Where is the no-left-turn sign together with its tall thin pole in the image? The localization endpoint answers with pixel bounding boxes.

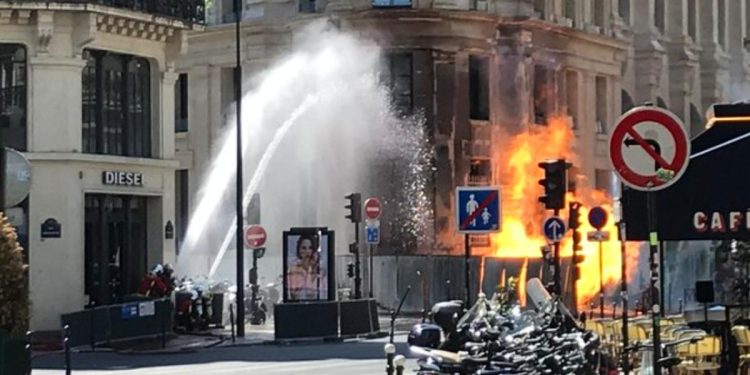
[609,106,690,374]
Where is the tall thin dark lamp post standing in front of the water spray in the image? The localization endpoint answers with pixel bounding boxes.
[234,0,247,337]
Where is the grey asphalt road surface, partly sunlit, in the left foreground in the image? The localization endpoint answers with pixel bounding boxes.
[33,337,415,375]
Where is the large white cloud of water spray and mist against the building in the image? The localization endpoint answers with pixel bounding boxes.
[177,23,432,282]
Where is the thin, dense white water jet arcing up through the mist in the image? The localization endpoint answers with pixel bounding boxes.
[208,93,320,278]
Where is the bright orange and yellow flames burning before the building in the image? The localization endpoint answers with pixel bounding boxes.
[492,117,638,307]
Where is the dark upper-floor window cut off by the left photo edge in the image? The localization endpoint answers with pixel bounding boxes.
[0,44,27,151]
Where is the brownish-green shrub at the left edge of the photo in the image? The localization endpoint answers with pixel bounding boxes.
[0,213,30,336]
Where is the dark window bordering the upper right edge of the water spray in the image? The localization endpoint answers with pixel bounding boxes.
[381,52,414,116]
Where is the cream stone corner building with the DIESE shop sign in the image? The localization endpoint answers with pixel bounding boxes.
[0,1,203,331]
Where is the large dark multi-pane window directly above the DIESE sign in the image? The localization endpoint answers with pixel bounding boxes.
[82,50,152,157]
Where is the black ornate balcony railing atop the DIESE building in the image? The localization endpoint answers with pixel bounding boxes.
[11,0,206,24]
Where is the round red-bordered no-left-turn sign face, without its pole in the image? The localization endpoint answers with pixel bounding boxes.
[609,107,690,190]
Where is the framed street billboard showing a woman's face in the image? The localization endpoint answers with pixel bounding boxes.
[284,228,334,302]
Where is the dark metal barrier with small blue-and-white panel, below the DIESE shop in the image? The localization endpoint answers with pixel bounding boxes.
[60,299,173,349]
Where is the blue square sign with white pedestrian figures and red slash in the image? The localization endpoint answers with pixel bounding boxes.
[456,186,502,234]
